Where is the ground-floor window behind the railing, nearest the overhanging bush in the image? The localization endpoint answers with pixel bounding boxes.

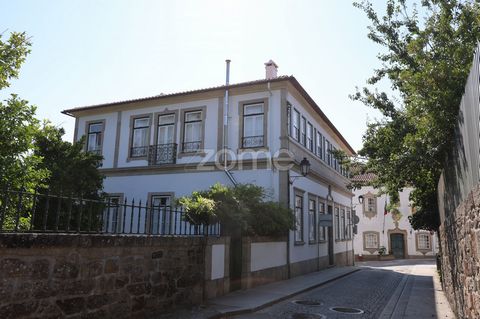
[150,195,172,234]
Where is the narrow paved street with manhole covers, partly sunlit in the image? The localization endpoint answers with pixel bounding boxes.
[235,260,455,319]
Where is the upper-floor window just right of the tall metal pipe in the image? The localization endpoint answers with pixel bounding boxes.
[242,103,264,148]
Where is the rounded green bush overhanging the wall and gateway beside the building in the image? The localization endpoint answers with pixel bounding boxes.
[178,183,294,236]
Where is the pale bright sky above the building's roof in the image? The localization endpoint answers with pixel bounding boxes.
[0,0,385,150]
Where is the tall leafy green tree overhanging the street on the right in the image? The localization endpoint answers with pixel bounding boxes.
[352,0,480,230]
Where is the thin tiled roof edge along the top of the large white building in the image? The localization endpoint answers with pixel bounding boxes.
[62,75,356,154]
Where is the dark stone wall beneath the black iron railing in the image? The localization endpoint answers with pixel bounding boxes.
[0,234,224,319]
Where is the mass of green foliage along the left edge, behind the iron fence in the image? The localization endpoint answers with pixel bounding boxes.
[0,32,103,230]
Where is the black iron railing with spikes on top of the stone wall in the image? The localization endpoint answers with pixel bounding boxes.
[0,189,220,236]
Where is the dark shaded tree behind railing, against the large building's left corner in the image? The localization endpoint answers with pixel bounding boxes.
[32,122,105,230]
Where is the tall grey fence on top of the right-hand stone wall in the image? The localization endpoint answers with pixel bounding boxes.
[438,44,480,222]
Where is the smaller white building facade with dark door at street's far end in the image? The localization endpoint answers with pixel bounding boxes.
[353,178,438,260]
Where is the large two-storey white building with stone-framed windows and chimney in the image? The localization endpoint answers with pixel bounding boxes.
[63,63,354,276]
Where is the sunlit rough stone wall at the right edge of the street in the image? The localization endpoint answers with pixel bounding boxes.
[440,186,480,319]
